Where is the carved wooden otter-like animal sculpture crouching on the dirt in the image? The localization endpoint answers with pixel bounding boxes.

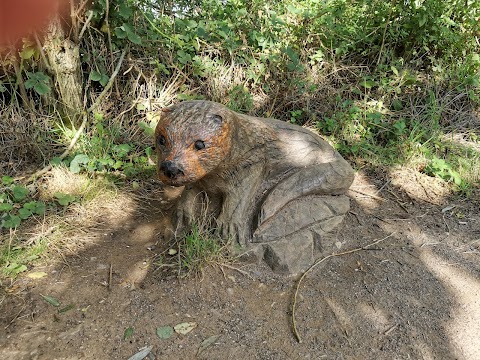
[155,101,354,272]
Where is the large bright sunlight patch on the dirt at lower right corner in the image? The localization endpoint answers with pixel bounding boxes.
[420,251,480,359]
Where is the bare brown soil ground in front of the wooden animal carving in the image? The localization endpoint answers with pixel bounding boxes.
[0,170,480,360]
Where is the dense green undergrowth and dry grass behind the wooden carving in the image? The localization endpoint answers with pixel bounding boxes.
[0,0,480,278]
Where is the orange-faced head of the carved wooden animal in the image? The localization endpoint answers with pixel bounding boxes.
[155,101,232,186]
